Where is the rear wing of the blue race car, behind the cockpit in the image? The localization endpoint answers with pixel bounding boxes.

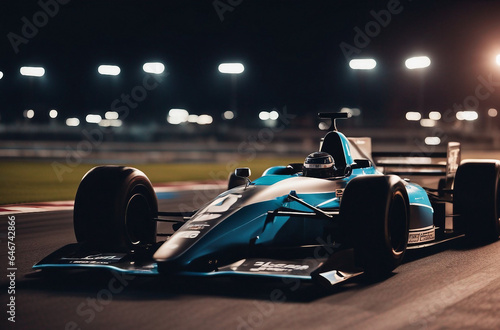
[372,142,461,181]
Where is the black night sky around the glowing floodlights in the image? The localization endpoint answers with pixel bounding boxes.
[0,0,500,123]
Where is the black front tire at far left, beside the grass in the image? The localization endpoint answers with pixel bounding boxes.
[73,166,158,251]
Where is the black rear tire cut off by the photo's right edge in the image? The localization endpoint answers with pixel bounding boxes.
[453,160,500,243]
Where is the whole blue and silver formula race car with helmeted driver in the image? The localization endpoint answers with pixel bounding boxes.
[33,113,500,285]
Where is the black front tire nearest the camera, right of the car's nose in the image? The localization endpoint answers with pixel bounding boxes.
[340,175,410,279]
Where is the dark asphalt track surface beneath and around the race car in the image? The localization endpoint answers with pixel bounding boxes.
[0,188,500,330]
